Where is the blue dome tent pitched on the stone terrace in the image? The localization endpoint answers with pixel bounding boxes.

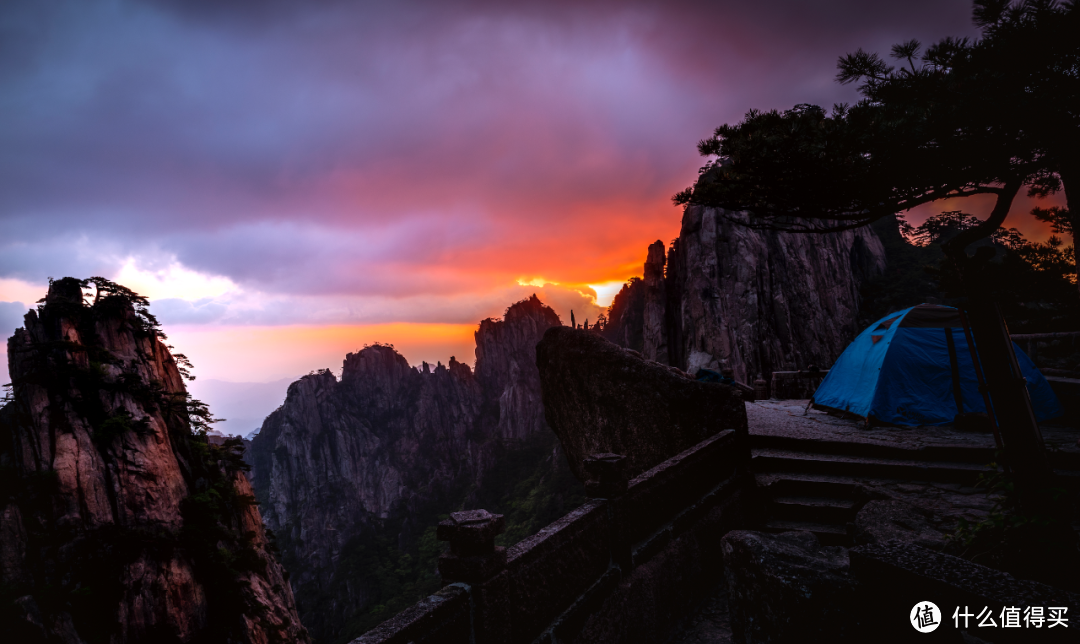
[813,304,1063,425]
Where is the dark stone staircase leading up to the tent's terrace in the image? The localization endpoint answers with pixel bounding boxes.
[751,434,1080,546]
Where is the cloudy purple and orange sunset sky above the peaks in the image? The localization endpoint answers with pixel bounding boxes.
[0,0,1062,432]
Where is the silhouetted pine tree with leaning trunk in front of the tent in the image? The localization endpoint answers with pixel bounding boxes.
[674,0,1080,497]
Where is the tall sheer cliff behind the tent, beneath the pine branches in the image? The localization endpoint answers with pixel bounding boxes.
[605,206,885,383]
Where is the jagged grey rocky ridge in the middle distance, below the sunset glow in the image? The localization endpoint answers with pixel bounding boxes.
[248,296,568,642]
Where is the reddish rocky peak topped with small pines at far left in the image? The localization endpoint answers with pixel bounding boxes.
[0,278,307,644]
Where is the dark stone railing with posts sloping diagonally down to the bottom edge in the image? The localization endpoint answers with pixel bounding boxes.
[353,430,753,644]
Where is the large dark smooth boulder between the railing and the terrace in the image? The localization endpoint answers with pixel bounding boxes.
[537,326,746,481]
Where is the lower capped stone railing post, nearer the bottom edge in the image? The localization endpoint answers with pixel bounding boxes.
[435,510,511,644]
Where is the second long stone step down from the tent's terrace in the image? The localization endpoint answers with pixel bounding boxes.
[751,448,987,485]
